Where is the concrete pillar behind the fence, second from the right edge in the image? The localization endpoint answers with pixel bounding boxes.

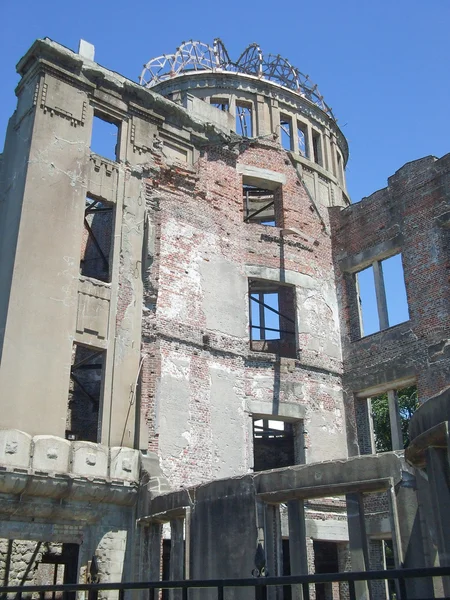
[395,472,433,599]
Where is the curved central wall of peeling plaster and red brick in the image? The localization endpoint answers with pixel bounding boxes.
[141,135,346,487]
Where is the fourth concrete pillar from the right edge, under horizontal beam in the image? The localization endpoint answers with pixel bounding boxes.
[287,500,308,600]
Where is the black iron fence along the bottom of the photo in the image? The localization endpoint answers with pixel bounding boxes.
[0,567,450,600]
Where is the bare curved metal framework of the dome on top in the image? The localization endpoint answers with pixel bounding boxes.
[139,38,334,119]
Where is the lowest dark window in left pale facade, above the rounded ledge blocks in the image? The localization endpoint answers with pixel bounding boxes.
[66,344,105,442]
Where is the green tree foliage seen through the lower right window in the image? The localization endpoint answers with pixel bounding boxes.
[372,385,419,452]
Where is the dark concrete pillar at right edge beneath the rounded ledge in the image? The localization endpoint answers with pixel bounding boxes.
[426,448,450,597]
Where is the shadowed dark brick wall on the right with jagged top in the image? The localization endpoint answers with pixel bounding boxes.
[330,155,450,451]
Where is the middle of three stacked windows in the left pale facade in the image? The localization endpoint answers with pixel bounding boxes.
[80,197,114,282]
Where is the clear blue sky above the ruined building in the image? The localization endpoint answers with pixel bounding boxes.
[0,0,450,332]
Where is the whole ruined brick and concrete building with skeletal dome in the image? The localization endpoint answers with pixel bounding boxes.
[0,39,450,599]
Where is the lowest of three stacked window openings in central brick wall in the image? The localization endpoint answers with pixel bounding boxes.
[253,418,295,471]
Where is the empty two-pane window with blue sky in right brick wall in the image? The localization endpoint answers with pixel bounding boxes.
[356,254,409,337]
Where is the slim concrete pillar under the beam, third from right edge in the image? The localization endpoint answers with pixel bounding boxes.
[346,492,370,600]
